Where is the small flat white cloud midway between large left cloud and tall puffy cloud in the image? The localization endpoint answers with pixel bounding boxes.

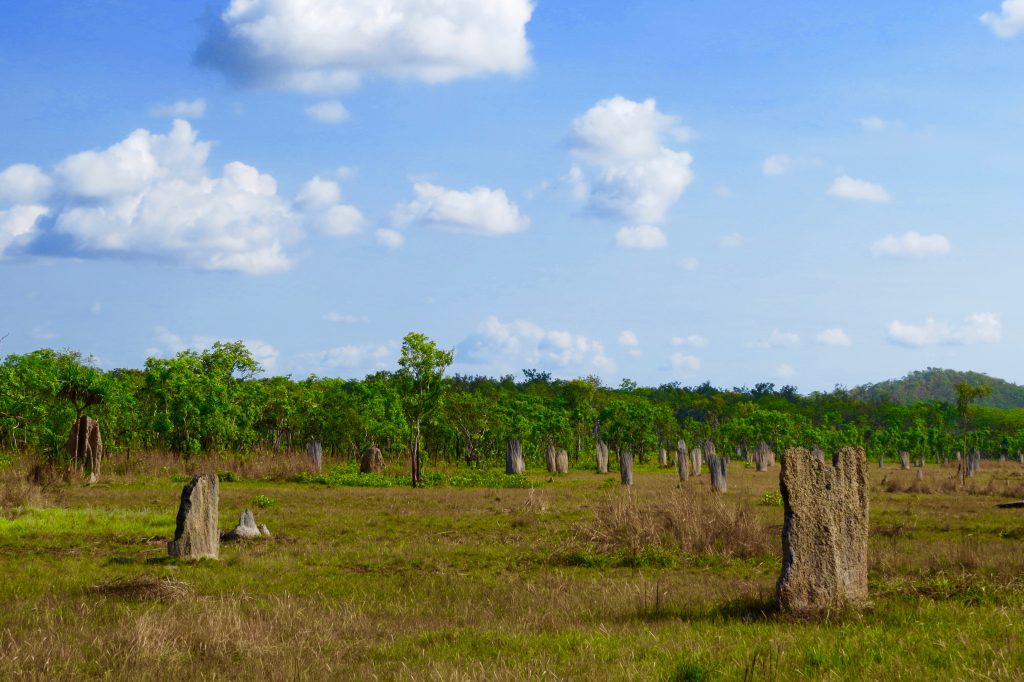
[392,182,529,236]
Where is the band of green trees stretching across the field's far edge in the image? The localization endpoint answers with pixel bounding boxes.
[0,333,1024,479]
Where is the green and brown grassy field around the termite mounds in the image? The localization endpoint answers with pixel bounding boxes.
[0,450,1024,680]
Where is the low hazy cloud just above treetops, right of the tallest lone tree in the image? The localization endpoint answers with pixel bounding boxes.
[456,315,615,376]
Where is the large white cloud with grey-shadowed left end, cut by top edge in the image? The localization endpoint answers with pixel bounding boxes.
[199,0,534,92]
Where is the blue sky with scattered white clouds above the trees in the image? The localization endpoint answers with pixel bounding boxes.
[0,0,1024,391]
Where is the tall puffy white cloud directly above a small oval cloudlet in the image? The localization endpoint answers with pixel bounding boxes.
[570,96,693,224]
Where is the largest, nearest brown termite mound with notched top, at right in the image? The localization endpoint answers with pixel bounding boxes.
[776,447,867,615]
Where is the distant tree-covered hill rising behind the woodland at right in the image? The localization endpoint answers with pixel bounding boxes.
[851,367,1024,408]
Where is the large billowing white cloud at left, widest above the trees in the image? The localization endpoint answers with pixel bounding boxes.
[55,119,300,274]
